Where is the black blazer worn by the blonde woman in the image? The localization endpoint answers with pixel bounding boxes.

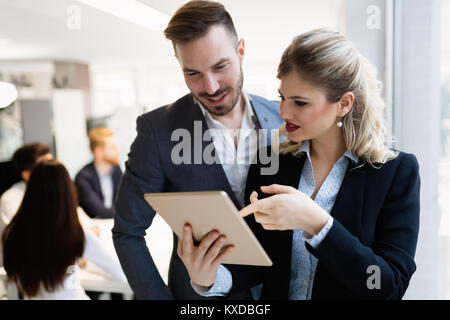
[230,148,420,299]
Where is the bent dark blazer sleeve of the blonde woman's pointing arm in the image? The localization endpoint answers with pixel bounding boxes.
[306,154,420,299]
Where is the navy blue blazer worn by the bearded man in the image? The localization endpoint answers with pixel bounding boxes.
[112,94,282,299]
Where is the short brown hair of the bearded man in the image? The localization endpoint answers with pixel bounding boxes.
[164,0,238,48]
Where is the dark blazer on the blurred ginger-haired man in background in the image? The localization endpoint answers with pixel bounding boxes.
[75,162,122,219]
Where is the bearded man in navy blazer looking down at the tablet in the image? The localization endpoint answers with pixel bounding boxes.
[113,1,281,299]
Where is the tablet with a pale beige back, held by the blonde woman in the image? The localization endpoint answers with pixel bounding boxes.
[144,191,272,266]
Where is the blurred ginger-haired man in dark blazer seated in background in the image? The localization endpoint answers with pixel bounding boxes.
[75,127,122,219]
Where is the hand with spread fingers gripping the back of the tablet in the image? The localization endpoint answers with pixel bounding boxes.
[177,224,234,288]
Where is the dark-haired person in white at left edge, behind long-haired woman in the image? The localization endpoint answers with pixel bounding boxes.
[0,143,53,266]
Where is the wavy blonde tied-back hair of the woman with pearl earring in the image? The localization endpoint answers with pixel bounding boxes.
[275,29,397,165]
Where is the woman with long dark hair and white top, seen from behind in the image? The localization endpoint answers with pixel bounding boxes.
[2,160,126,300]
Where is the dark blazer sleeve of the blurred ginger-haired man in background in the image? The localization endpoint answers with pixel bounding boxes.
[75,172,115,219]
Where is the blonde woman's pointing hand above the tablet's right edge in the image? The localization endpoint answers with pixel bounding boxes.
[239,184,329,235]
